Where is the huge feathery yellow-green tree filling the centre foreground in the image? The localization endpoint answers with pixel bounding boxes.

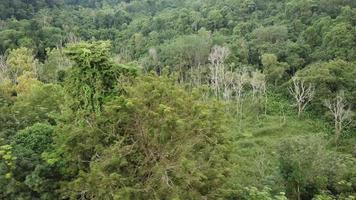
[61,75,230,199]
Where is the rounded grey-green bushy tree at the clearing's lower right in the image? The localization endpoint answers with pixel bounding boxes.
[278,136,330,200]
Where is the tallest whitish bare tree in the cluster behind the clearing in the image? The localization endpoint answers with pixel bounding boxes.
[209,46,230,97]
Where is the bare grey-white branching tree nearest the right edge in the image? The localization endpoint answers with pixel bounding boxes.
[325,93,352,145]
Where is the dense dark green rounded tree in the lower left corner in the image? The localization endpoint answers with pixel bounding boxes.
[0,124,59,200]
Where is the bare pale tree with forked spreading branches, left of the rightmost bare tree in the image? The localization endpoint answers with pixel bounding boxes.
[289,77,315,117]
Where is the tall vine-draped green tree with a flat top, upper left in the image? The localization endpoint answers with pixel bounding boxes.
[65,41,136,112]
